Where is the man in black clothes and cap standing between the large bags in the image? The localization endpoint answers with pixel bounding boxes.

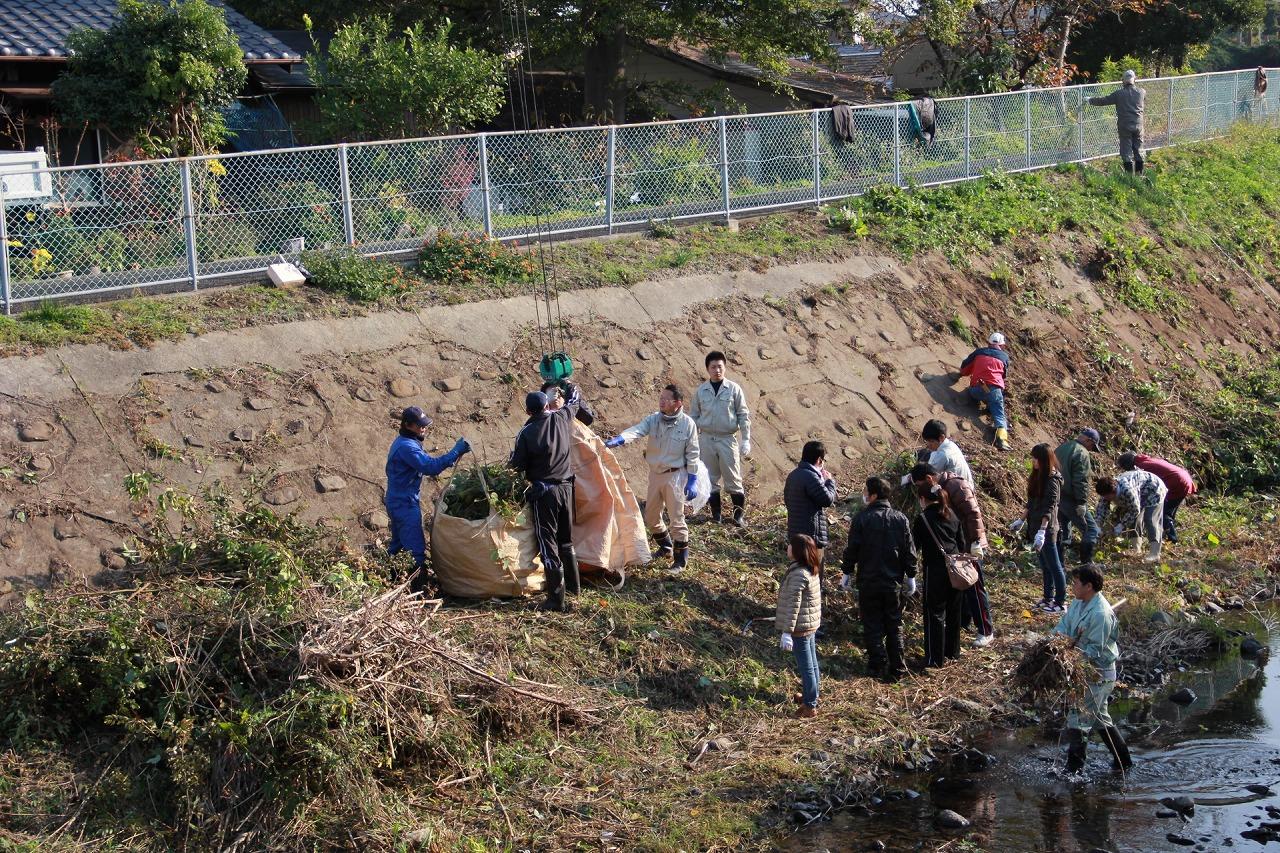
[511,386,581,611]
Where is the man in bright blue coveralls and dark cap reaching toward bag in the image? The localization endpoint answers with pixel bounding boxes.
[384,406,471,592]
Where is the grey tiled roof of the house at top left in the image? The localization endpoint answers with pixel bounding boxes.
[0,0,302,63]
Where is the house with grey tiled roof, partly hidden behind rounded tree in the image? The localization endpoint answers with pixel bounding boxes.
[0,0,303,165]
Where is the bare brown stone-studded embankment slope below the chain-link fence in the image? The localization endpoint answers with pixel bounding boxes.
[0,230,1280,593]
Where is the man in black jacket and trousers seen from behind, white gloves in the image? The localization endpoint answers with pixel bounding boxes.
[841,476,915,681]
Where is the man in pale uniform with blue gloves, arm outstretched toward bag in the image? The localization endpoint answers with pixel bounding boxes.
[604,386,699,573]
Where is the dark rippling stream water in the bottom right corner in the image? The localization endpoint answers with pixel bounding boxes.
[783,617,1280,853]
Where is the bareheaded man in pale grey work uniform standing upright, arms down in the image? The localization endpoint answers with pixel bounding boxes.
[689,351,751,528]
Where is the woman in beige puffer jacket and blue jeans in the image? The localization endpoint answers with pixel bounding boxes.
[773,533,822,719]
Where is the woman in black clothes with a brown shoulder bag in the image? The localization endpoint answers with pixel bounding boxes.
[911,483,964,666]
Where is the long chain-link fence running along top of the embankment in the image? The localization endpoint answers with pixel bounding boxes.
[0,70,1280,313]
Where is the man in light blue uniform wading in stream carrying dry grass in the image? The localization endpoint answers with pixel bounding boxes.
[1053,565,1133,774]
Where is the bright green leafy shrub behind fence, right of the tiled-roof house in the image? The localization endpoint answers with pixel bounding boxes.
[307,15,506,140]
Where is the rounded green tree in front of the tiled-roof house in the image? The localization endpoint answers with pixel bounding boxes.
[52,0,247,156]
